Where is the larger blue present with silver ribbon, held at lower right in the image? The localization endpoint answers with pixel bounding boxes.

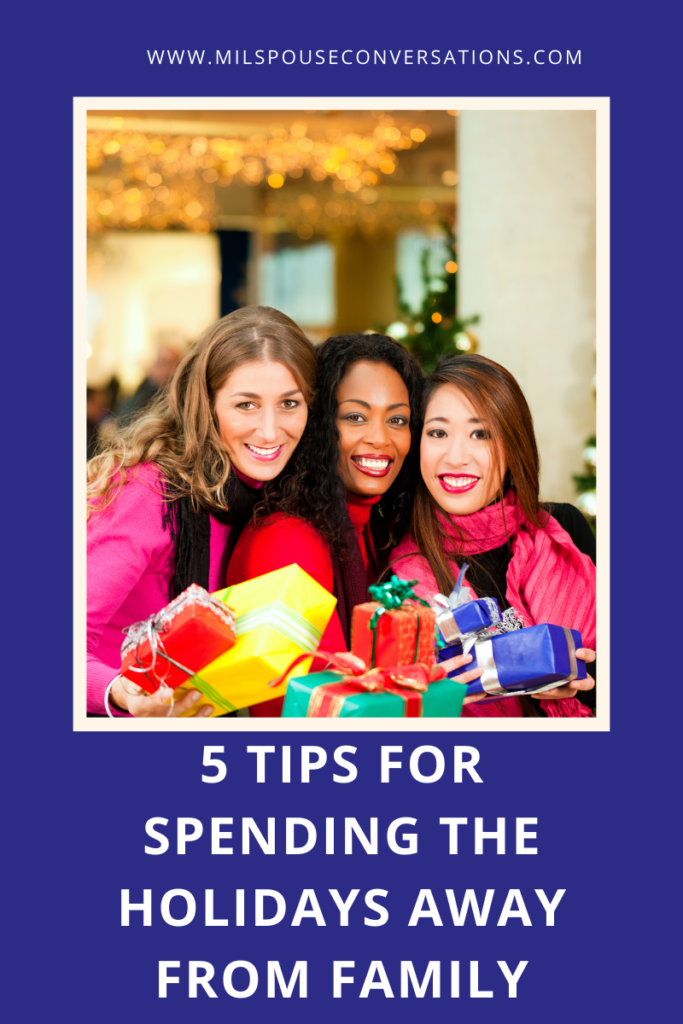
[438,609,587,699]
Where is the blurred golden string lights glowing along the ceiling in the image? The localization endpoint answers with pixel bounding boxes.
[87,112,457,240]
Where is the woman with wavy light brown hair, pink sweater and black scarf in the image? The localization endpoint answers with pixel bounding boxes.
[88,306,315,717]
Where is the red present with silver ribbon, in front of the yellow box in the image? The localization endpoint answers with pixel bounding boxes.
[121,584,234,693]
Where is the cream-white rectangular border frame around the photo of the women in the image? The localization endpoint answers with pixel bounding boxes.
[73,96,610,733]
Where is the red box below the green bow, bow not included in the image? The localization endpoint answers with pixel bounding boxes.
[351,601,436,669]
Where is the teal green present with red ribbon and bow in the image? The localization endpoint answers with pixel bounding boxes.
[283,664,467,718]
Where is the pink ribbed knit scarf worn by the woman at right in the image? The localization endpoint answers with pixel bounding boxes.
[391,492,596,718]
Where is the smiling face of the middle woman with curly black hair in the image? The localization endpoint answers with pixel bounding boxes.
[335,362,411,497]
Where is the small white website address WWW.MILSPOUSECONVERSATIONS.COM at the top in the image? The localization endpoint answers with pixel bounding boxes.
[147,49,581,68]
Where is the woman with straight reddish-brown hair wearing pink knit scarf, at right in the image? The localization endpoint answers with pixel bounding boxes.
[392,355,595,717]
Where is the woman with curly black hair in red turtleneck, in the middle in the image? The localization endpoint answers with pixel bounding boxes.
[227,334,423,684]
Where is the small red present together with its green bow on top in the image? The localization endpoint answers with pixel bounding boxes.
[351,575,435,669]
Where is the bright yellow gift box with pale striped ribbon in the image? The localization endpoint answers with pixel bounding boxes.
[176,564,337,717]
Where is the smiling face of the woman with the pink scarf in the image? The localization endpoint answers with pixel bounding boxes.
[420,384,506,515]
